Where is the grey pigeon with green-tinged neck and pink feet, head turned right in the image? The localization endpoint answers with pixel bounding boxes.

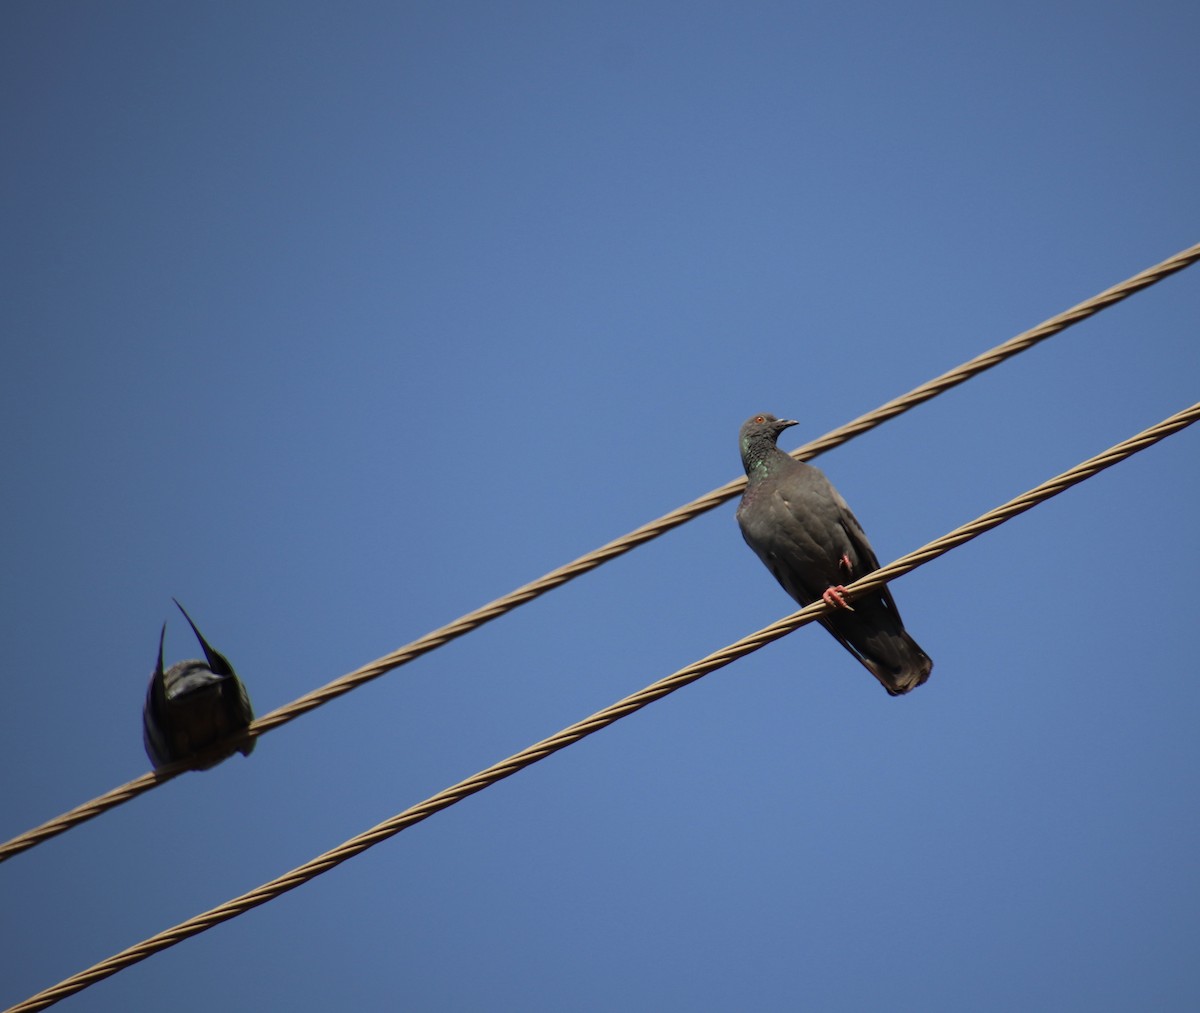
[738,414,934,696]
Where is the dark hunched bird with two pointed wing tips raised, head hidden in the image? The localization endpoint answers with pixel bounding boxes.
[142,599,254,771]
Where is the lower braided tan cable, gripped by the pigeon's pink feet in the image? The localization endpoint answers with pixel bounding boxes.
[7,402,1200,1013]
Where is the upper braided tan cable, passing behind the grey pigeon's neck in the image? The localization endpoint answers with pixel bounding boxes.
[0,244,1200,862]
